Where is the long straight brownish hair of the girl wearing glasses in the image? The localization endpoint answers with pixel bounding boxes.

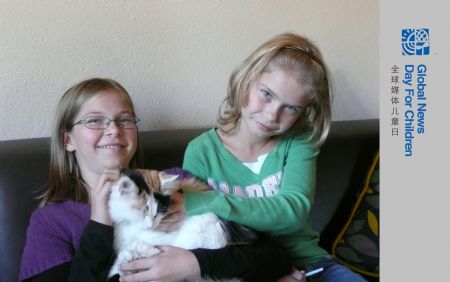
[38,78,141,206]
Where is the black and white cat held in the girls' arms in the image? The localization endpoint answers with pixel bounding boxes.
[108,171,257,277]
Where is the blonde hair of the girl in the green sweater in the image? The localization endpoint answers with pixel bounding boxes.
[218,33,332,147]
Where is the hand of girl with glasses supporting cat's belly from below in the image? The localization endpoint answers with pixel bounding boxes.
[119,246,200,282]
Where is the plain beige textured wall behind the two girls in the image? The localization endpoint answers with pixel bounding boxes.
[0,0,379,140]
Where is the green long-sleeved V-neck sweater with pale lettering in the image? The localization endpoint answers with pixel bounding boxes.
[183,128,328,268]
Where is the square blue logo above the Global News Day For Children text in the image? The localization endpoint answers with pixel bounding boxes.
[402,28,430,56]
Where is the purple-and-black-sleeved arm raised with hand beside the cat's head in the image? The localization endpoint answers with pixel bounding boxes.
[24,171,119,282]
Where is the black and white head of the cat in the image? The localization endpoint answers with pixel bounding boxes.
[109,171,170,229]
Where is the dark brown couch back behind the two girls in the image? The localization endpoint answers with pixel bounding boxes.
[0,120,379,282]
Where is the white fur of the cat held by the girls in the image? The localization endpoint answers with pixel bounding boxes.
[109,174,227,276]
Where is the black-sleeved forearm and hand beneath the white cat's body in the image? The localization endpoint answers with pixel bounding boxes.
[120,234,292,282]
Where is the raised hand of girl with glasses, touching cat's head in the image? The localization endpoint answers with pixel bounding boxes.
[90,170,120,225]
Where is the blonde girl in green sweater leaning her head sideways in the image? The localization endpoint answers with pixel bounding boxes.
[121,33,365,282]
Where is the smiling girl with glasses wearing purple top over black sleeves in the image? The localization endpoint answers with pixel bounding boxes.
[19,78,290,282]
